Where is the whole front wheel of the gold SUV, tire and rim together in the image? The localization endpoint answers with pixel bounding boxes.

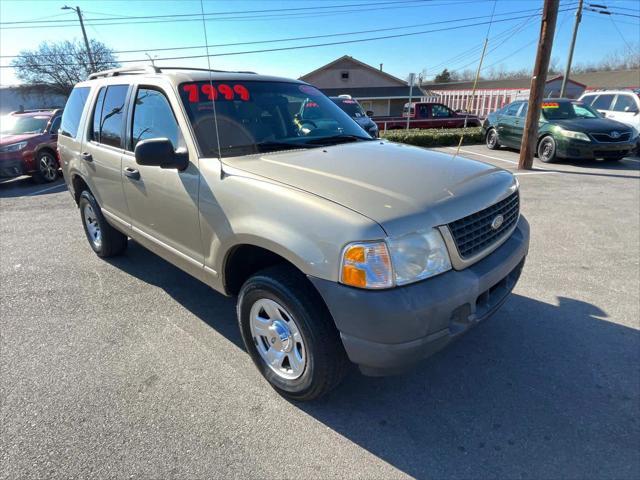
[237,266,349,401]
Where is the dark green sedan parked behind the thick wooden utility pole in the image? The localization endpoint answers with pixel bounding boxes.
[482,98,638,162]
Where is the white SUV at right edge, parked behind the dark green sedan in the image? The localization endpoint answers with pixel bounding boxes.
[580,90,640,154]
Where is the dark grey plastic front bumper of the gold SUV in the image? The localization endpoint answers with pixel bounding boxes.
[310,217,529,375]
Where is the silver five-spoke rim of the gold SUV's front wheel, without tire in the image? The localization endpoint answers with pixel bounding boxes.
[249,298,307,380]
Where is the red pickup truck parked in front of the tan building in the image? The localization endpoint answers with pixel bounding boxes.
[373,102,480,131]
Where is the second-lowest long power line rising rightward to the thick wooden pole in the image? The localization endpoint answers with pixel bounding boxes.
[0,8,552,58]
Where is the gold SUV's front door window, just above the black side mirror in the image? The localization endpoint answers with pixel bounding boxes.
[131,88,182,150]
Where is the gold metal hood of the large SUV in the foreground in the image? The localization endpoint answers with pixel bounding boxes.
[223,141,517,235]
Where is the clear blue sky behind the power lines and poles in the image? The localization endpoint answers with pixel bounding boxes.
[0,0,640,85]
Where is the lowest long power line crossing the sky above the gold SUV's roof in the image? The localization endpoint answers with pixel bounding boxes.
[0,10,566,68]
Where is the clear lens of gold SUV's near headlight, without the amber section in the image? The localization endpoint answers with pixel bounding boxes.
[389,228,451,285]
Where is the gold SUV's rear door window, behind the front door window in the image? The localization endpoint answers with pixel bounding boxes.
[92,85,129,147]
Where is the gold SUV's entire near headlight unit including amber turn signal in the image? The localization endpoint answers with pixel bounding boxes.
[340,228,451,289]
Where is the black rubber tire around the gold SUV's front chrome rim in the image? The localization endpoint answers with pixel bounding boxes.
[237,265,350,401]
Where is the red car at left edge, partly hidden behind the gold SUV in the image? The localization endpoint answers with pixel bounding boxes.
[0,109,62,183]
